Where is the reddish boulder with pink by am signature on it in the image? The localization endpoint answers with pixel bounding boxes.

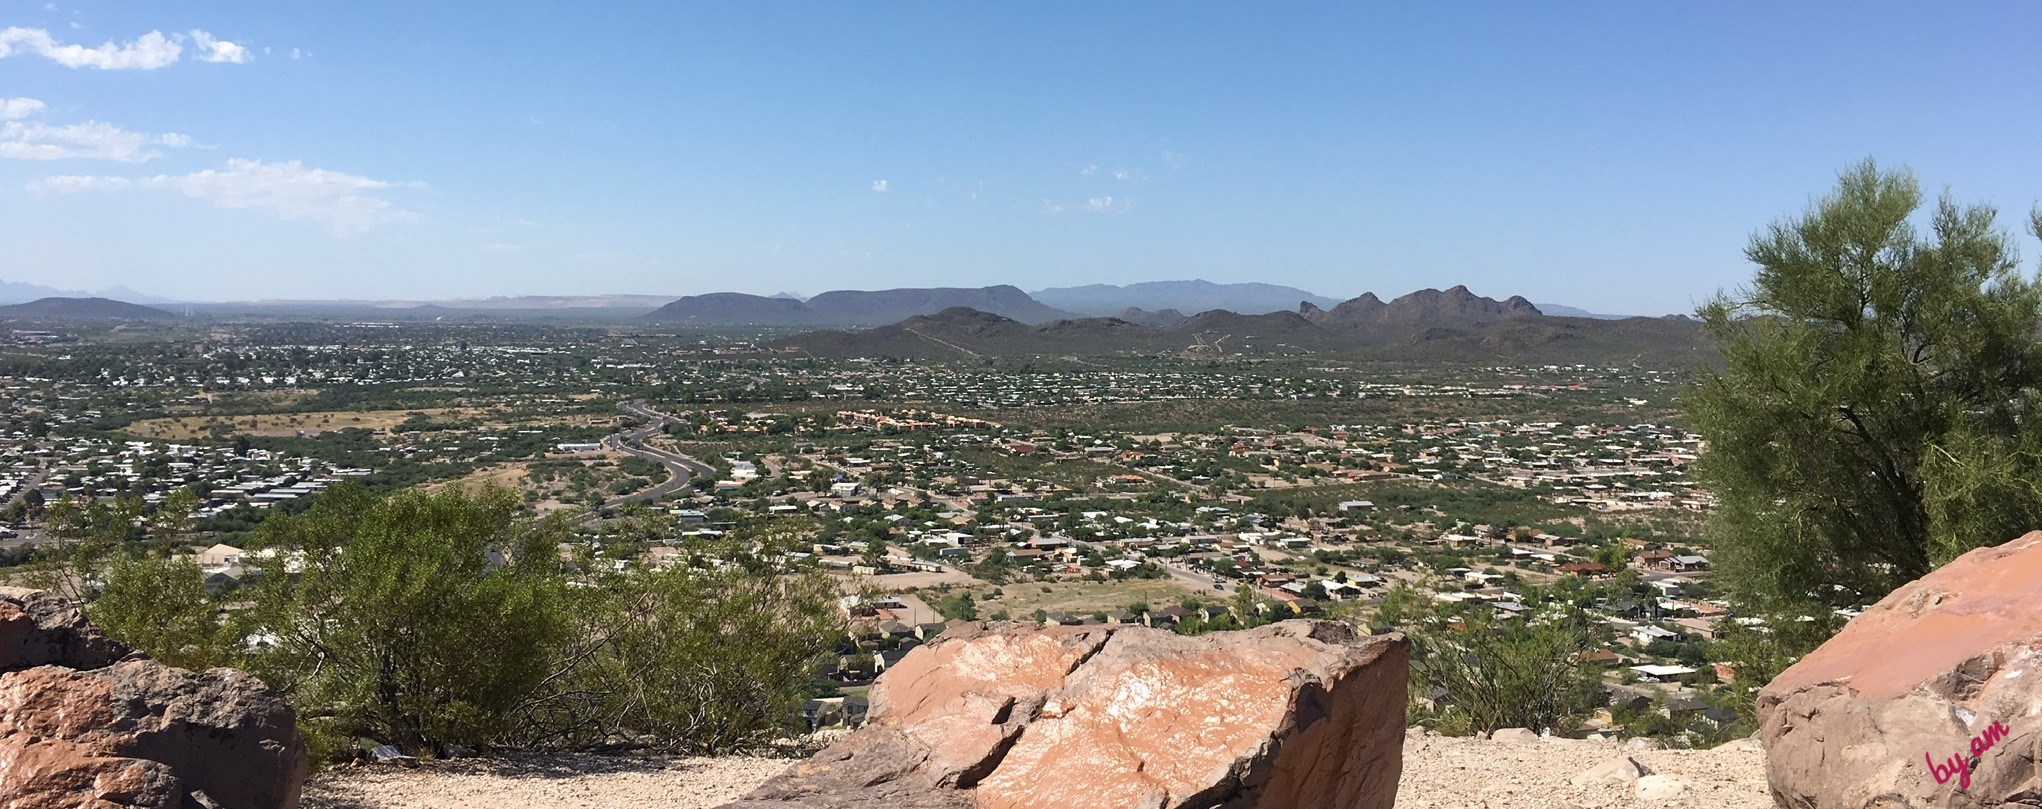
[1758,531,2042,809]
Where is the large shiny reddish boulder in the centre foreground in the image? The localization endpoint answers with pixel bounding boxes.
[725,621,1409,809]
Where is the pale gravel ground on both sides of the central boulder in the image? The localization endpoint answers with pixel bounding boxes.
[304,735,1772,809]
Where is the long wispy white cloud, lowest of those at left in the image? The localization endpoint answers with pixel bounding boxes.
[29,159,417,235]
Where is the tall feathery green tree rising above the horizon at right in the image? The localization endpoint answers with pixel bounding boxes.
[1687,161,2042,625]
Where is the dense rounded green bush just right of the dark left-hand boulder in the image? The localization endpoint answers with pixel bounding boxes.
[251,484,568,754]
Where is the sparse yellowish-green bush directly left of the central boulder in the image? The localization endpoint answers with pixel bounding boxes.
[508,521,845,754]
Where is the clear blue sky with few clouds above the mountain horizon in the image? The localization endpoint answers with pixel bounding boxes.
[0,0,2042,315]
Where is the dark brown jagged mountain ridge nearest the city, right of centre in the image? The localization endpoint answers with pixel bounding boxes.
[770,286,1715,366]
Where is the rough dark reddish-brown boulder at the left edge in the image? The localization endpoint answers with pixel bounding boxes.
[0,588,306,809]
